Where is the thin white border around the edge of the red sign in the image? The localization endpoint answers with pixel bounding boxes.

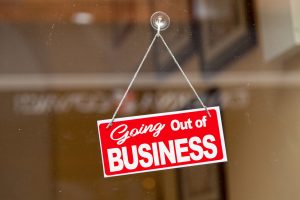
[97,106,227,178]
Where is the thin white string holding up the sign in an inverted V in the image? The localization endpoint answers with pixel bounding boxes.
[106,18,211,128]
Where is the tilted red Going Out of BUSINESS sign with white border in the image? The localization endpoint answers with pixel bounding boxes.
[98,107,227,177]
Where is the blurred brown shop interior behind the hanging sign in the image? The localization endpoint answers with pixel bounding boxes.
[0,0,300,200]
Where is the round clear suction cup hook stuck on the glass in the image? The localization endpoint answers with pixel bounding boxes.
[150,11,170,31]
